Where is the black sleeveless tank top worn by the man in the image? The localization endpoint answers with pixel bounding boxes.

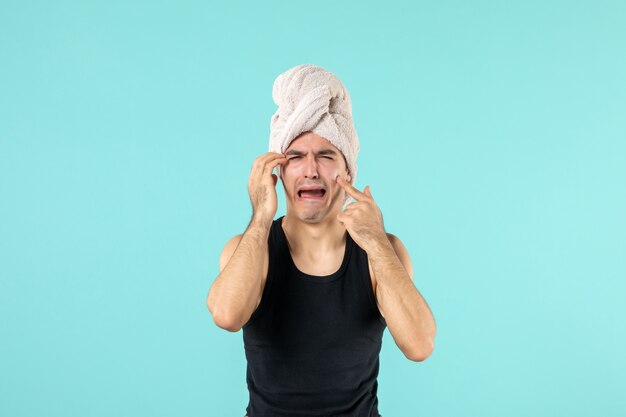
[243,216,386,417]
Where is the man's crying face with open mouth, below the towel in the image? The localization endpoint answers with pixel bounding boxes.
[281,132,350,221]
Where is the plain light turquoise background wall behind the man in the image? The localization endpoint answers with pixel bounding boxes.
[0,0,626,417]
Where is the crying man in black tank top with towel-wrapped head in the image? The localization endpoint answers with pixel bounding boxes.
[207,65,436,417]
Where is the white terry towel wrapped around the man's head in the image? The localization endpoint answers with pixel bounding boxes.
[269,64,359,208]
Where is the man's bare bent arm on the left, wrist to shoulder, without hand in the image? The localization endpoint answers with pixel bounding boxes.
[207,217,272,332]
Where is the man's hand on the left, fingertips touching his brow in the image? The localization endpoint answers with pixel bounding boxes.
[248,152,287,222]
